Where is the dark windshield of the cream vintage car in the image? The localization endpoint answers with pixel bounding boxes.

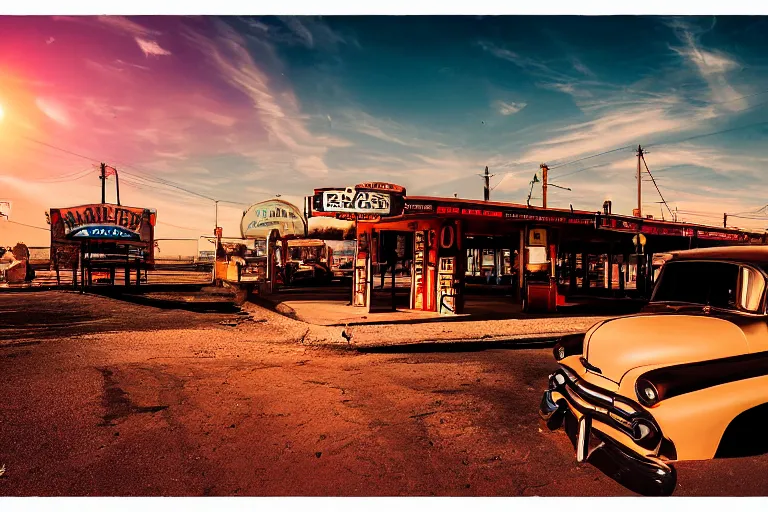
[652,261,765,312]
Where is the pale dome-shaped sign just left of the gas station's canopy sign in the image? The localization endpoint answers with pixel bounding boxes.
[240,199,306,238]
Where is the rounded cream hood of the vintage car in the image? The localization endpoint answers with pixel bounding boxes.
[584,314,749,384]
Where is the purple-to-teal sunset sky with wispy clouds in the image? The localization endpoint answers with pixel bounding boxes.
[0,16,768,246]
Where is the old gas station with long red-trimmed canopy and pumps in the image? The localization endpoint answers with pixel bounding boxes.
[305,182,768,314]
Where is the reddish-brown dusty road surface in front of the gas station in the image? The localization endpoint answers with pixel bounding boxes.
[0,292,768,496]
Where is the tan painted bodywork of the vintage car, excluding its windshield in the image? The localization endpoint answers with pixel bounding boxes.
[541,247,768,494]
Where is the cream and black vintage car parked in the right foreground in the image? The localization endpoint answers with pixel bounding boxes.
[540,247,768,494]
